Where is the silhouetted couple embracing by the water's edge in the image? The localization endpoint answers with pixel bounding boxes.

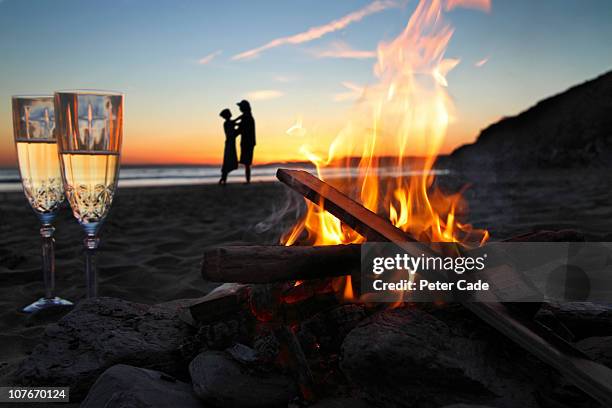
[219,100,255,186]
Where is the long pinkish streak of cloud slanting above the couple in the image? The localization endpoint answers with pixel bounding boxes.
[232,0,397,61]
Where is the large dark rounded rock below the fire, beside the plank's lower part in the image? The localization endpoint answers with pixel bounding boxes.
[341,308,549,407]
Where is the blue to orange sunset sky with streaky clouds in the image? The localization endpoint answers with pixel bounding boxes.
[0,0,612,166]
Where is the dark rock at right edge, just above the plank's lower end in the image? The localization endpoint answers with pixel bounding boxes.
[536,302,612,340]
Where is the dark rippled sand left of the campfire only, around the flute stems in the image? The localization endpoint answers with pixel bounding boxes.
[0,183,296,364]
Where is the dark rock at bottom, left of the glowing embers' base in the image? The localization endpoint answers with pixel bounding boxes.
[189,351,298,408]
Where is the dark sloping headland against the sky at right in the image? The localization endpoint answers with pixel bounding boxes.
[450,72,612,171]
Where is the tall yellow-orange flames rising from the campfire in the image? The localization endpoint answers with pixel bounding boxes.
[281,0,491,298]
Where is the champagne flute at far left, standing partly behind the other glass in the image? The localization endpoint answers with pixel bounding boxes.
[12,96,72,313]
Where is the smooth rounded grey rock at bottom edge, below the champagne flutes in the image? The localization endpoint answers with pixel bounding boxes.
[81,364,203,408]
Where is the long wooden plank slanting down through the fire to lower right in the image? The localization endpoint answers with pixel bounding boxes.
[276,169,612,407]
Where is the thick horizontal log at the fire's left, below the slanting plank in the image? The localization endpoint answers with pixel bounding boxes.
[202,244,361,283]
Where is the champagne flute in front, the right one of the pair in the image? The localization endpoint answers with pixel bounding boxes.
[55,90,123,298]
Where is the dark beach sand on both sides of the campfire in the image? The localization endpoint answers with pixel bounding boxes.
[0,170,612,372]
